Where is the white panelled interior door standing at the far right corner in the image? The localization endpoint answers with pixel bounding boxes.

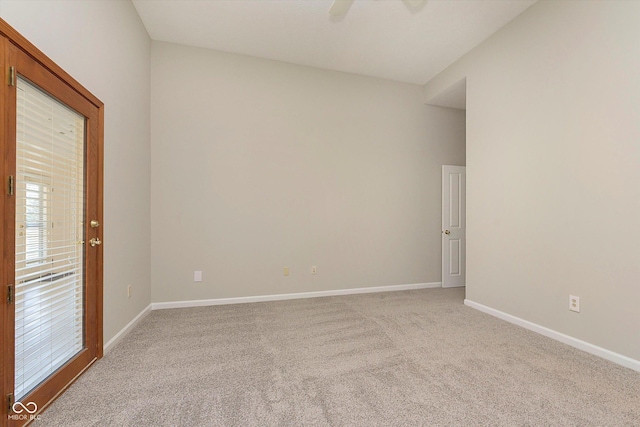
[442,166,466,288]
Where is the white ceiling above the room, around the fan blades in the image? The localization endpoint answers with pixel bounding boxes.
[133,0,535,84]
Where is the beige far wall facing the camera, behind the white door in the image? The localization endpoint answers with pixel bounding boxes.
[151,42,465,302]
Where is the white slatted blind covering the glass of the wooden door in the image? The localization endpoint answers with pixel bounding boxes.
[14,78,85,400]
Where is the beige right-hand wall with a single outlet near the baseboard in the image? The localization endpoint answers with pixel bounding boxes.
[425,1,640,360]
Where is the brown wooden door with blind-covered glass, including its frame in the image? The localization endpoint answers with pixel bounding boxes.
[0,21,103,426]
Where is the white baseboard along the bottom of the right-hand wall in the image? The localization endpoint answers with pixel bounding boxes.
[464,299,640,372]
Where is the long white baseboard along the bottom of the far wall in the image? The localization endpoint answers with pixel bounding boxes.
[151,282,442,310]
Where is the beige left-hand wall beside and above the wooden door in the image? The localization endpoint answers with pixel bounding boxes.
[0,0,151,343]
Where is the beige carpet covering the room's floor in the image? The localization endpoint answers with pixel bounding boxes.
[33,289,640,427]
